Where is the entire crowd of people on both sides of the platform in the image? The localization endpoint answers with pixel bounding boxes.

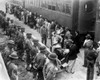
[0,4,100,80]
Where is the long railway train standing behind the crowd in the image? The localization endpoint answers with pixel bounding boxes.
[10,0,100,41]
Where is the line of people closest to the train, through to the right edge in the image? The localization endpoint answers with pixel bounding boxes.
[4,2,100,80]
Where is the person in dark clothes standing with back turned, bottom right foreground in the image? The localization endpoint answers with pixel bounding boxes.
[86,45,97,80]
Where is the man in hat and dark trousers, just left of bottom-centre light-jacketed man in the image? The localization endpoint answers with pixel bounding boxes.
[34,46,46,80]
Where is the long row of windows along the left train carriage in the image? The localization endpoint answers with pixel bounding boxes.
[27,0,72,14]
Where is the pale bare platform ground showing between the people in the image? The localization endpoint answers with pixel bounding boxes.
[0,0,100,80]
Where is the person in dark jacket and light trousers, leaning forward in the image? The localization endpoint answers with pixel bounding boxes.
[66,40,78,73]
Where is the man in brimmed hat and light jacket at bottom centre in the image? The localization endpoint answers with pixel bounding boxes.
[43,53,61,80]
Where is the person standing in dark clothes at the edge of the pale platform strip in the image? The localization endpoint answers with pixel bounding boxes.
[40,25,48,45]
